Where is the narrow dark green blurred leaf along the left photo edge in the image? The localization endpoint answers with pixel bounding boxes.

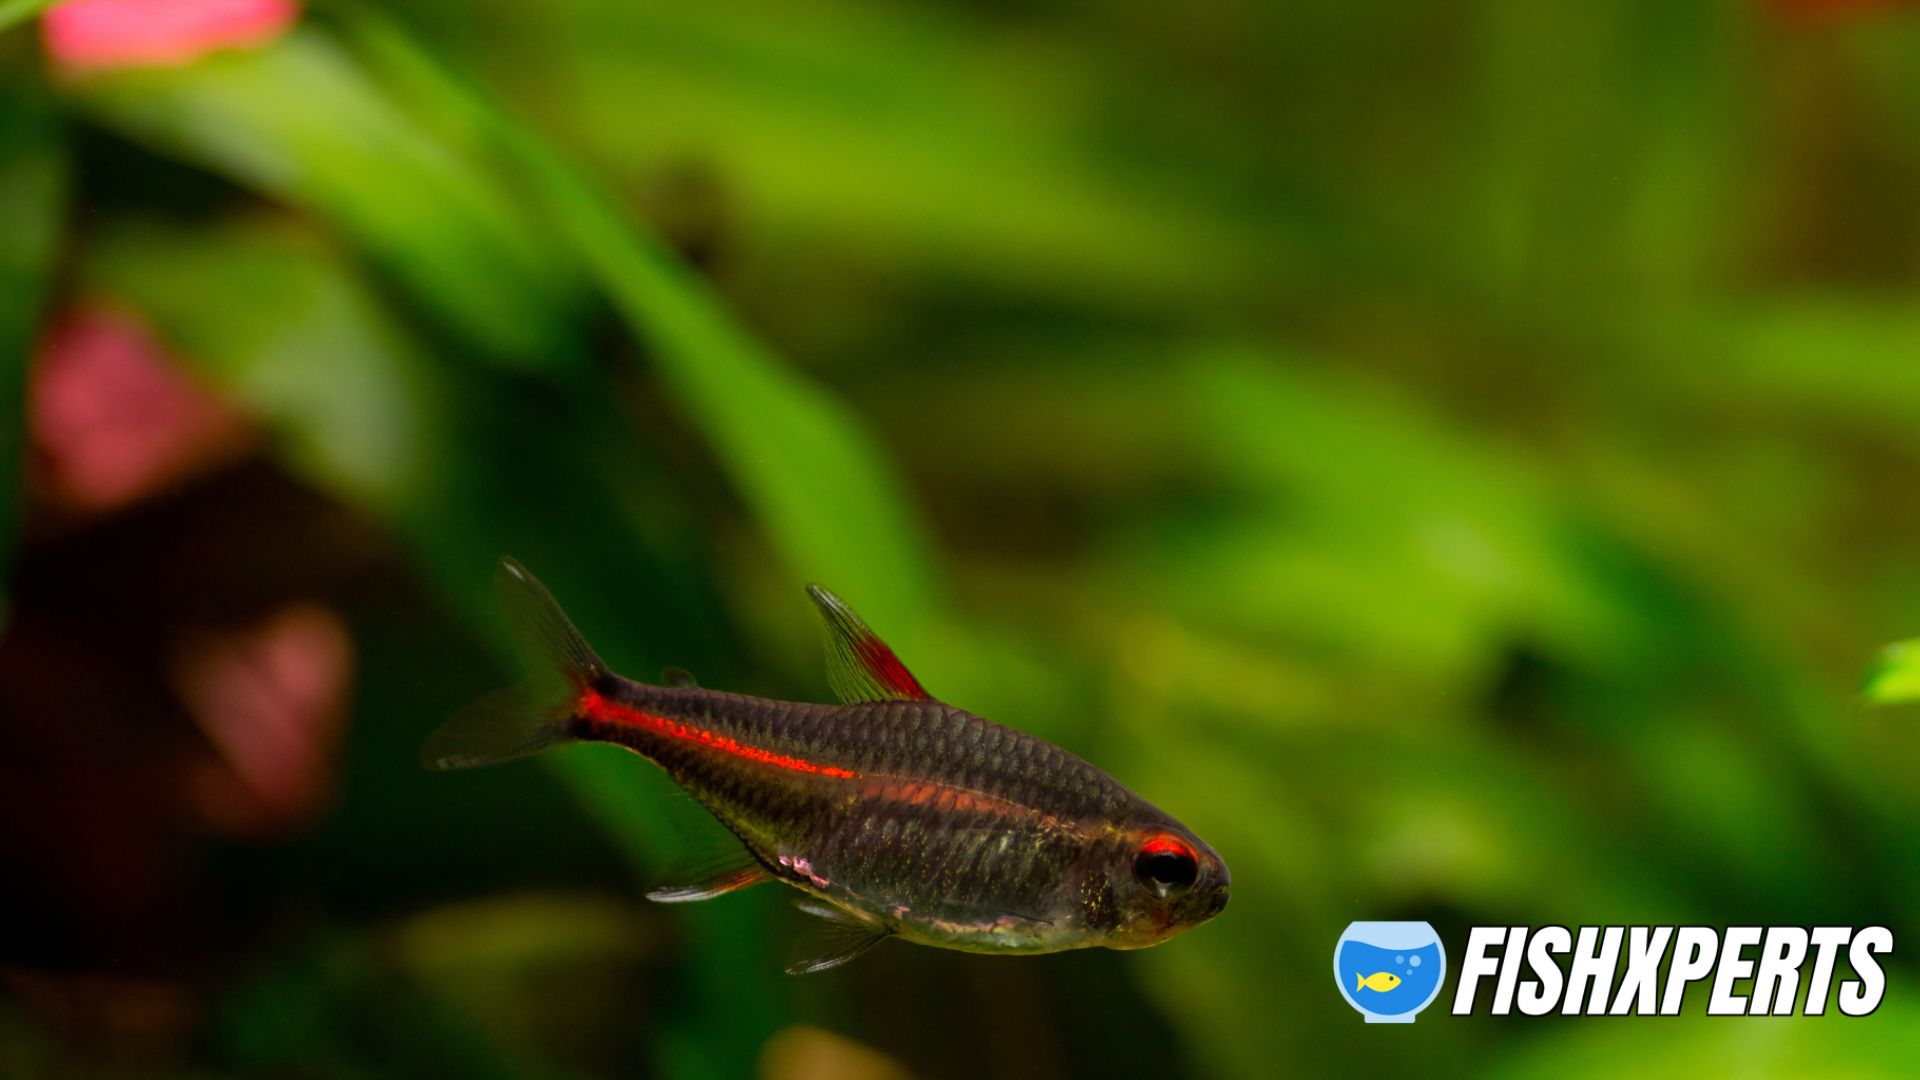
[0,58,67,623]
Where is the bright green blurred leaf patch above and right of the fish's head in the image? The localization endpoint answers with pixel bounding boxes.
[1082,348,1632,684]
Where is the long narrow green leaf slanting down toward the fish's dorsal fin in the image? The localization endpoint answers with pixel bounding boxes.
[353,15,952,648]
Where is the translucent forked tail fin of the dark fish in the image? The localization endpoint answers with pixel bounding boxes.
[420,559,607,769]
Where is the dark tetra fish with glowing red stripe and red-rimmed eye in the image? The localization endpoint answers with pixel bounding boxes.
[420,559,1229,972]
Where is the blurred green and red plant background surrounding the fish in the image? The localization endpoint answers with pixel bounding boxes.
[0,0,1920,1078]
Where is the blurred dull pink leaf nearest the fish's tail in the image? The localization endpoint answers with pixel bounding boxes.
[175,603,353,834]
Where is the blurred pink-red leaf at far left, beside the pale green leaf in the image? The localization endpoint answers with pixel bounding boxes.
[27,309,253,511]
